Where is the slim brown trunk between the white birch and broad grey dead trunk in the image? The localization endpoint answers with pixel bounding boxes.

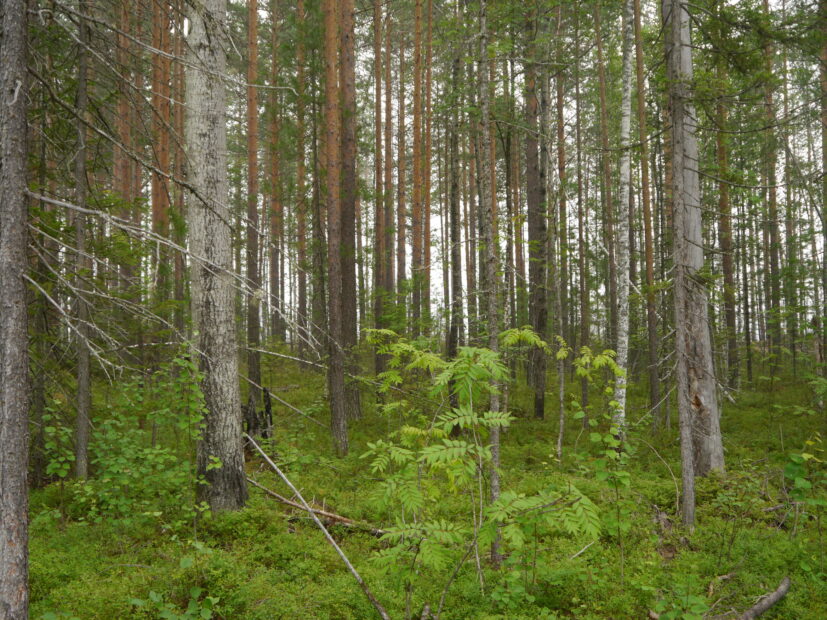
[634,0,660,412]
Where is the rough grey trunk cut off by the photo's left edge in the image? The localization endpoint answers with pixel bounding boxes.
[0,0,29,620]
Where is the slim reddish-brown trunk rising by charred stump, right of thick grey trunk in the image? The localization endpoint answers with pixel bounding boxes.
[247,0,261,407]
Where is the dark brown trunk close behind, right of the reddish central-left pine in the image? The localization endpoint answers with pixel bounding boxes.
[338,0,362,418]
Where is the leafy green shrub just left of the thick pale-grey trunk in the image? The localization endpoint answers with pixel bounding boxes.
[44,357,209,529]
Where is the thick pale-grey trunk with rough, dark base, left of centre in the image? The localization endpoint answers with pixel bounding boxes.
[184,0,247,511]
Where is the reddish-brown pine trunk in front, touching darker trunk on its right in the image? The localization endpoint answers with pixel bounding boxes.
[322,0,348,456]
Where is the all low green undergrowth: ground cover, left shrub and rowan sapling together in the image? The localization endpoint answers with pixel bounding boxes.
[30,342,827,620]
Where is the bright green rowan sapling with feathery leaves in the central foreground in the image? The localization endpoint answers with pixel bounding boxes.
[362,330,601,609]
